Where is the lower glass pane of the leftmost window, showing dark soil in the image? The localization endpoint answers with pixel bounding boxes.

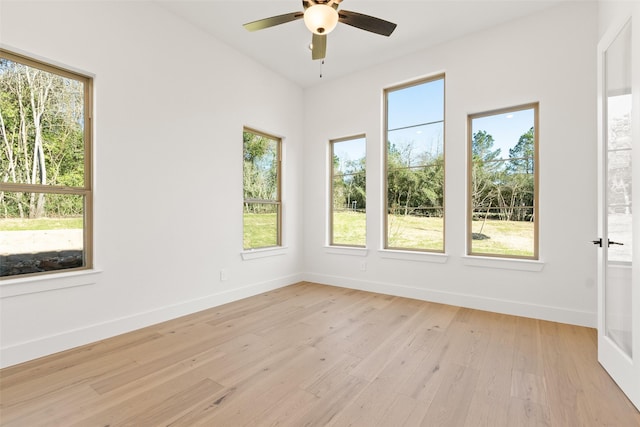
[0,192,85,276]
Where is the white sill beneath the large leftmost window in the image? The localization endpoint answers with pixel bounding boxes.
[0,270,102,299]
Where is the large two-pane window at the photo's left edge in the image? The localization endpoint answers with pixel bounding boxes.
[0,49,92,278]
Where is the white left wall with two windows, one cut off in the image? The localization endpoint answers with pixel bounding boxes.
[0,1,303,366]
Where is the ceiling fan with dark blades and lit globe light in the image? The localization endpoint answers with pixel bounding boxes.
[244,0,396,59]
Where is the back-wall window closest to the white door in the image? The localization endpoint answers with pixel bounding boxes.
[467,104,539,259]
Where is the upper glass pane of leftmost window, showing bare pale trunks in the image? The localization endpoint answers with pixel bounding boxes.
[0,58,85,187]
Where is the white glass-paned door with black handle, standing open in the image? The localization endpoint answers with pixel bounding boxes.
[594,11,640,408]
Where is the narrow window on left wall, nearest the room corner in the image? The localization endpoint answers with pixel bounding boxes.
[242,129,282,249]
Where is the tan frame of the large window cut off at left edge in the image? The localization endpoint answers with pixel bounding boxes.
[0,48,94,281]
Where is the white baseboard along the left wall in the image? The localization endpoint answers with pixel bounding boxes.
[0,274,303,368]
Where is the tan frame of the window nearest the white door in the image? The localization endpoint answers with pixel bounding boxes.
[466,101,540,261]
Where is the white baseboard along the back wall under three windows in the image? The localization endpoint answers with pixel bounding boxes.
[304,273,597,328]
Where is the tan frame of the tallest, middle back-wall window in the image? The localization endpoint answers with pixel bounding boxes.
[382,72,447,255]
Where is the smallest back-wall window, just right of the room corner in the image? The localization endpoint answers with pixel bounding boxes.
[330,136,367,246]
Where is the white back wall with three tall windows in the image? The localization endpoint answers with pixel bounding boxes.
[304,2,598,326]
